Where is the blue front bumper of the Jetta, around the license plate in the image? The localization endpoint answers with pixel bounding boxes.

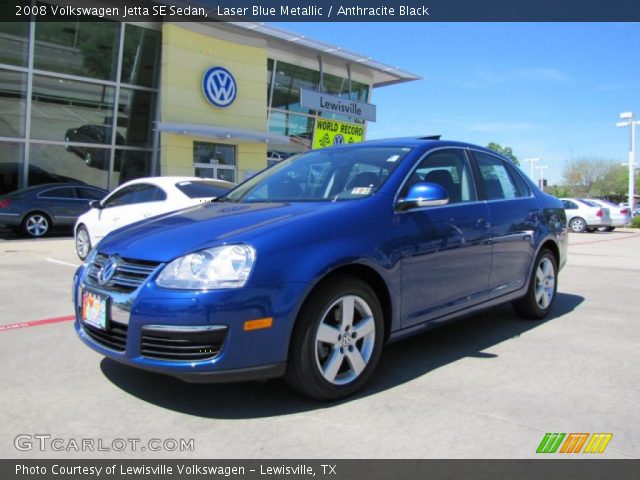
[74,267,306,382]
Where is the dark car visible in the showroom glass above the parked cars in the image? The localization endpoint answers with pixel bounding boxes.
[64,125,125,171]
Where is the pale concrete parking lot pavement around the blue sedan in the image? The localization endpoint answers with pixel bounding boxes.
[0,230,640,459]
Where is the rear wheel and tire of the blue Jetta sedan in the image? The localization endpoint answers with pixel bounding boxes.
[513,249,558,320]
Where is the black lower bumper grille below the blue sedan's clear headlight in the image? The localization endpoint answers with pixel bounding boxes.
[140,327,227,361]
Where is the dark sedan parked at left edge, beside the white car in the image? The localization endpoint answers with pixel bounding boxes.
[0,183,109,237]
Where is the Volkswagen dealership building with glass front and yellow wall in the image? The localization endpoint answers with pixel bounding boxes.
[0,21,419,193]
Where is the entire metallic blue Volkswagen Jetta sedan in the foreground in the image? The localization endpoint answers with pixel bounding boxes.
[74,138,567,399]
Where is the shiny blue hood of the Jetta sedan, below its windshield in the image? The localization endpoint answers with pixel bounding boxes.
[97,202,352,262]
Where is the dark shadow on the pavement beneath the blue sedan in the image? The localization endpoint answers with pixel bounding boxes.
[100,292,584,419]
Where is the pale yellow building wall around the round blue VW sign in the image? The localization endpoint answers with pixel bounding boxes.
[160,23,267,181]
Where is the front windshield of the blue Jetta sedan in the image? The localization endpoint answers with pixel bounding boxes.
[224,146,411,203]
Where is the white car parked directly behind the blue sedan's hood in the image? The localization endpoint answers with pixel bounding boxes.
[74,177,234,260]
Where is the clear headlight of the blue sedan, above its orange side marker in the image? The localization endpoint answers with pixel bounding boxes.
[156,245,256,290]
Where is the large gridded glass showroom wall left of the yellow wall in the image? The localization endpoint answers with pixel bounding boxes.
[0,21,162,191]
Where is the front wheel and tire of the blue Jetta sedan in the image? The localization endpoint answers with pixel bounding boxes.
[285,275,384,400]
